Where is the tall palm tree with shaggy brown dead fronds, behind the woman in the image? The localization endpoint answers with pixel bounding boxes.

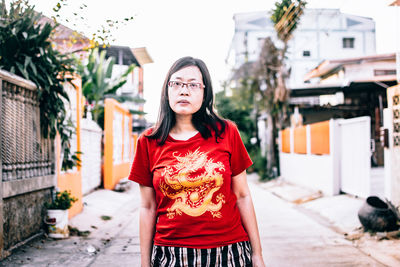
[256,0,306,178]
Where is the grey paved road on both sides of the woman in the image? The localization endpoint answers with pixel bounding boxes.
[0,178,385,267]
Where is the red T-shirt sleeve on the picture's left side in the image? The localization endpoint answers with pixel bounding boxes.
[128,134,153,187]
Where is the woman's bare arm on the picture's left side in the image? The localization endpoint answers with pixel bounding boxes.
[139,185,156,267]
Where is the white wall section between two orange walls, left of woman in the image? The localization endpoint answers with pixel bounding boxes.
[81,119,102,195]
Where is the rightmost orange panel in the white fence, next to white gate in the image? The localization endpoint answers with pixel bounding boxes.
[310,121,329,155]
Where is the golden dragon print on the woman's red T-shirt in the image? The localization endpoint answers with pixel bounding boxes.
[160,149,225,219]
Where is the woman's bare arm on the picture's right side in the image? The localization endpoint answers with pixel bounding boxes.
[232,171,265,267]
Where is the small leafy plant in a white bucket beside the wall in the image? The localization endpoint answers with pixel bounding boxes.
[45,190,78,238]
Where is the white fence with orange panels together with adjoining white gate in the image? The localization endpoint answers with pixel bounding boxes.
[279,117,374,197]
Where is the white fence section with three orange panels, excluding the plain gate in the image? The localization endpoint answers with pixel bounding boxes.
[279,120,339,195]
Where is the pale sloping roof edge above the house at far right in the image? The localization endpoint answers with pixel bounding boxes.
[304,53,396,81]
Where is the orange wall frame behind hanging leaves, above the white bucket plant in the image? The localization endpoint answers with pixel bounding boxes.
[56,78,83,218]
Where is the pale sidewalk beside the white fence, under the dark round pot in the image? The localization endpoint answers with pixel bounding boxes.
[253,178,400,267]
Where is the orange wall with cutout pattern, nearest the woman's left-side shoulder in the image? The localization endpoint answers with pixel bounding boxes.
[103,99,133,189]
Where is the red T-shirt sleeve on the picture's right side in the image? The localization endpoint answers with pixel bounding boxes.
[228,122,253,176]
